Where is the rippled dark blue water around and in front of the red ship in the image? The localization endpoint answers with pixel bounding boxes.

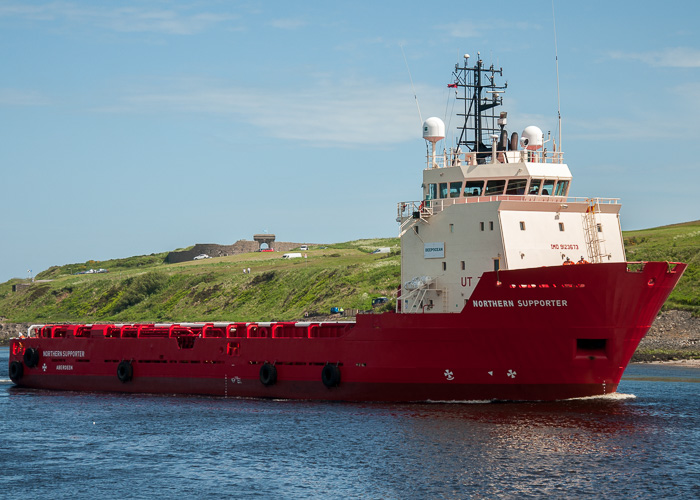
[0,348,700,499]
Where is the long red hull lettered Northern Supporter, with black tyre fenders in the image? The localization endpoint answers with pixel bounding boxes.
[10,262,685,401]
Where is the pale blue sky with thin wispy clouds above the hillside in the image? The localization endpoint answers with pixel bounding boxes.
[0,0,700,281]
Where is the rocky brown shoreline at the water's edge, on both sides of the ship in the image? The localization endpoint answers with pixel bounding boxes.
[0,311,700,365]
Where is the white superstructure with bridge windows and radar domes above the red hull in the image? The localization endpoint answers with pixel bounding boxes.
[397,54,625,313]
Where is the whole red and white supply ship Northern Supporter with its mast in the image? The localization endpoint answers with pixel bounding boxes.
[9,56,686,401]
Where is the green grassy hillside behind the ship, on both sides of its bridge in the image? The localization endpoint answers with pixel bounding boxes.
[0,221,700,323]
